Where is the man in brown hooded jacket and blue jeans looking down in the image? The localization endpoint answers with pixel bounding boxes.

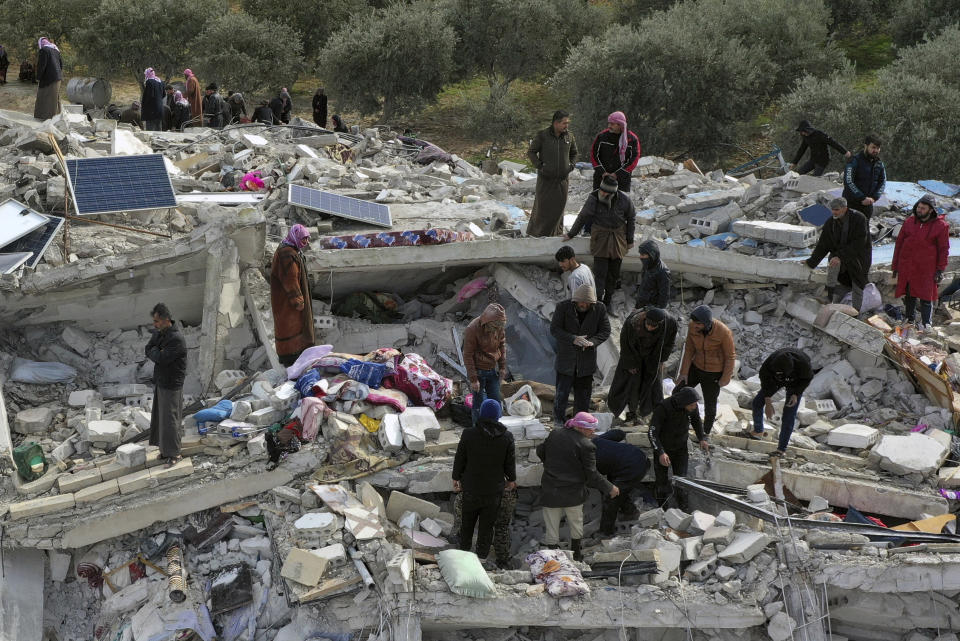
[463,303,507,425]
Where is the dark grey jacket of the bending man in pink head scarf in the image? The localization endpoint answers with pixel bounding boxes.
[537,427,613,507]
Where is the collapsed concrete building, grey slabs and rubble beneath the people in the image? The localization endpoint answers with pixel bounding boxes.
[0,104,960,641]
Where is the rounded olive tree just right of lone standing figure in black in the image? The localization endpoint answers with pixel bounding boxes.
[319,0,456,122]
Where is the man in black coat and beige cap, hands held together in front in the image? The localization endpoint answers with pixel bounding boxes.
[550,285,610,425]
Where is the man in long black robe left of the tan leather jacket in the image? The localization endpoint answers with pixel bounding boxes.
[607,307,677,423]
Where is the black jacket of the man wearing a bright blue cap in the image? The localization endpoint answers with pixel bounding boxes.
[453,418,517,496]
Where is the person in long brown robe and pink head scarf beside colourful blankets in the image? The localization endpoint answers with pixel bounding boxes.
[270,224,315,366]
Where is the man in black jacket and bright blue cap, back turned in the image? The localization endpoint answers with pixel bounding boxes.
[453,398,517,562]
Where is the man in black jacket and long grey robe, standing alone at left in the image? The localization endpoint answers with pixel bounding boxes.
[144,303,187,467]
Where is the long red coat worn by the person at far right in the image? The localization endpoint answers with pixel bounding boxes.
[893,215,950,300]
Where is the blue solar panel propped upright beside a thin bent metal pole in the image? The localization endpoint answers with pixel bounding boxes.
[67,154,177,216]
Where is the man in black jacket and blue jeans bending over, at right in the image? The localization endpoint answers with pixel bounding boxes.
[746,347,813,457]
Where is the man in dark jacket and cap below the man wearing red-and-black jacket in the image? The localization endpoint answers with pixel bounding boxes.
[563,176,637,310]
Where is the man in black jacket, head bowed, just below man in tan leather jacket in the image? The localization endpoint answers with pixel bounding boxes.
[650,387,710,507]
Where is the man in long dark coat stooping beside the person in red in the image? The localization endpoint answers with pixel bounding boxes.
[805,198,873,311]
